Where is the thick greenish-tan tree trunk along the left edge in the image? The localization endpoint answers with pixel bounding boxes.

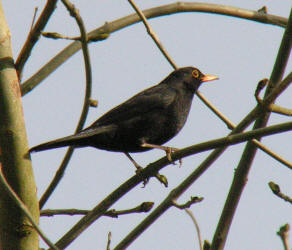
[0,0,39,250]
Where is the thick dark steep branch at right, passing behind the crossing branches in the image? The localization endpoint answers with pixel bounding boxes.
[211,6,292,250]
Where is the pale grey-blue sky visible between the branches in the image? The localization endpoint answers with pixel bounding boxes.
[3,0,292,250]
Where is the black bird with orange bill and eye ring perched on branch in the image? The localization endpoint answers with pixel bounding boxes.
[29,67,218,161]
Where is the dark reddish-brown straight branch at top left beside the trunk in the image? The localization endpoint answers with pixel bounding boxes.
[15,0,57,77]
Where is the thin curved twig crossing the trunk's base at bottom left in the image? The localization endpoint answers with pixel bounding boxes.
[0,165,59,250]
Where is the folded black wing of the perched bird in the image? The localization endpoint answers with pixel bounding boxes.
[89,84,176,129]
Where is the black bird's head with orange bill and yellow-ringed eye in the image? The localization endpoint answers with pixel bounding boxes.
[170,67,219,92]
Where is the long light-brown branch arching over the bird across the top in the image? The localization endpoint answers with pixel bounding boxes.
[21,2,287,95]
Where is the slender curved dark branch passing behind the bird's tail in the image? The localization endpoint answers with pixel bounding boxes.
[39,0,92,208]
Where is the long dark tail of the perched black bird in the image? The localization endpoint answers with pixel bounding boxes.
[29,125,115,153]
